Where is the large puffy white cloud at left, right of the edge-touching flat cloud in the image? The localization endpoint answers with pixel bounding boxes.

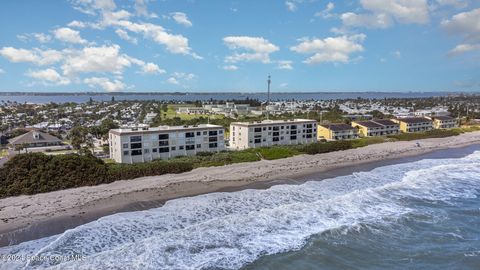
[62,45,132,76]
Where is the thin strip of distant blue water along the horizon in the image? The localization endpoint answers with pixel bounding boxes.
[0,92,459,103]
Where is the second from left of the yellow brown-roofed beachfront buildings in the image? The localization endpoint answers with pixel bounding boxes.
[352,119,400,137]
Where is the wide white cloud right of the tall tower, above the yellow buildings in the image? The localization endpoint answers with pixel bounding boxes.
[290,34,366,64]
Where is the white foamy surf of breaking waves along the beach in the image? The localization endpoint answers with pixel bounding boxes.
[0,152,480,269]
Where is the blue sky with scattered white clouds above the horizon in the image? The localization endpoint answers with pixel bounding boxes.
[0,0,480,92]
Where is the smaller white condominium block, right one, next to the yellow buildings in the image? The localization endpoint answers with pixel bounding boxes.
[230,119,317,149]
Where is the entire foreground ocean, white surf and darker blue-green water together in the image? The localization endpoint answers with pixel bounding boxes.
[0,151,480,270]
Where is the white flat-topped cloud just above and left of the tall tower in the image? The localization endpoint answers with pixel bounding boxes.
[223,36,279,63]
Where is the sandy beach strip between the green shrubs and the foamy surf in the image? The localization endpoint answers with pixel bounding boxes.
[0,131,480,246]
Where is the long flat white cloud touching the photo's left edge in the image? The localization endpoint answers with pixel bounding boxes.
[0,47,63,65]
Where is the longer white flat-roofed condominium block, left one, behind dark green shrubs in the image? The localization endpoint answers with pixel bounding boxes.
[108,124,225,163]
